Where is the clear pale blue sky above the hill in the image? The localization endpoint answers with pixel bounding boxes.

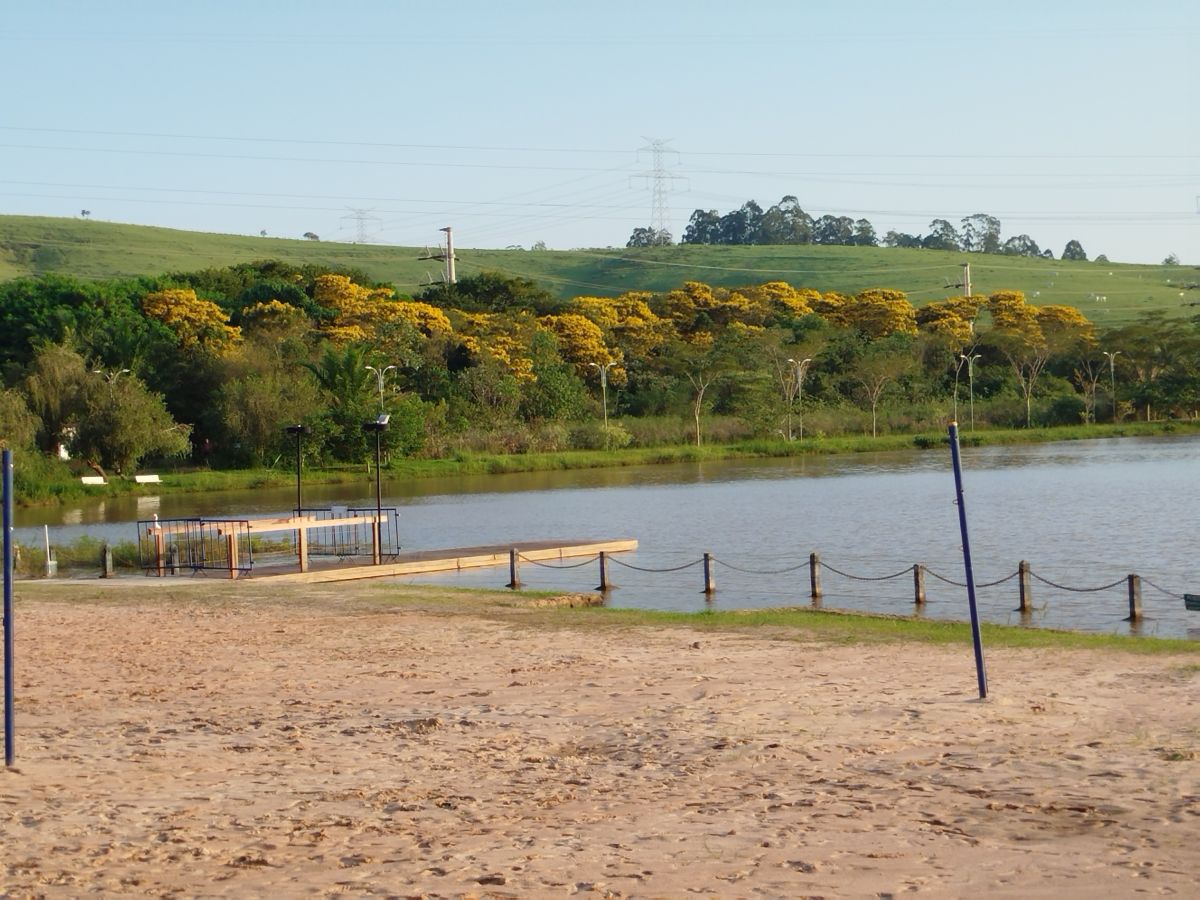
[0,0,1200,263]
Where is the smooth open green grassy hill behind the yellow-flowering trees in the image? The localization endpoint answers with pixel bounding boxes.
[0,216,1200,325]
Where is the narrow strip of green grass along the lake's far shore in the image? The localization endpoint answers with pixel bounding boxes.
[16,421,1200,505]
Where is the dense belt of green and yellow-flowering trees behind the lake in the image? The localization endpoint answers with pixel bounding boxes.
[0,262,1200,494]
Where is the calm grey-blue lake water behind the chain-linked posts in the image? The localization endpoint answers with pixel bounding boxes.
[17,436,1200,637]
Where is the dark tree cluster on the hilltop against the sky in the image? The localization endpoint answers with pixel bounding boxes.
[625,194,1087,260]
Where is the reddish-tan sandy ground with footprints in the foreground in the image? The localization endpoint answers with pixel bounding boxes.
[0,578,1200,898]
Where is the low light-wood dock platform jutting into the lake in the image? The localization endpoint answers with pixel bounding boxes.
[242,538,637,584]
